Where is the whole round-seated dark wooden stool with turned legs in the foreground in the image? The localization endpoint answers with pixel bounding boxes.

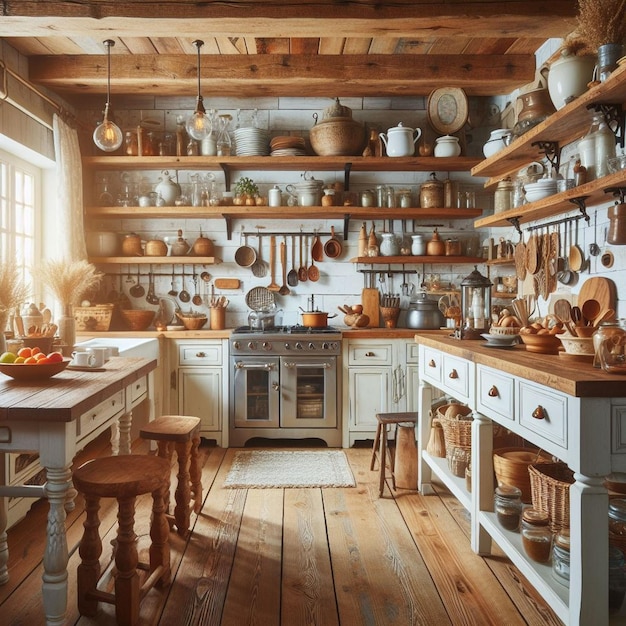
[73,454,170,626]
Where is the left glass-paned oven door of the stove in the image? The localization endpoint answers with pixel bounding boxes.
[231,356,280,428]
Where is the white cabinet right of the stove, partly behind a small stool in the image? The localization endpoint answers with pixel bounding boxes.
[343,339,419,447]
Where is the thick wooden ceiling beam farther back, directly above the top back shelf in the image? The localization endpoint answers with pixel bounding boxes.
[29,54,535,97]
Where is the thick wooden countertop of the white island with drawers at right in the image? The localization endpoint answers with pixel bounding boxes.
[415,331,626,398]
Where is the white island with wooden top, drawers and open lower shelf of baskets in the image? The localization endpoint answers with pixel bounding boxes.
[415,332,626,624]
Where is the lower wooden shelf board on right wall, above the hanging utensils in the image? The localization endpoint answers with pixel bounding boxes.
[474,170,626,228]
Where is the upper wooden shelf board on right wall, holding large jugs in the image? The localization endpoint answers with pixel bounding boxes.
[471,63,626,186]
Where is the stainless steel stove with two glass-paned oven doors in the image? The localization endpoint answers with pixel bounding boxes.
[229,326,341,446]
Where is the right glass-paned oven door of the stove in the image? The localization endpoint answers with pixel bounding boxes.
[280,355,338,428]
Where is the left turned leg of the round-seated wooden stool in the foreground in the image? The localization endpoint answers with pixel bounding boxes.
[77,495,102,616]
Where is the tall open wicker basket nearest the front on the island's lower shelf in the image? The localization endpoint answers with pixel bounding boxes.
[528,463,574,533]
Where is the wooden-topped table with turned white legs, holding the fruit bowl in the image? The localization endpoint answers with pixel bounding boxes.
[0,357,157,625]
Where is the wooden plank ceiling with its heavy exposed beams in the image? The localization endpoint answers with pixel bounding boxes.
[0,0,576,106]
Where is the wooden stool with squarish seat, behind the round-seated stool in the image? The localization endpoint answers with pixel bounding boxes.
[139,415,202,536]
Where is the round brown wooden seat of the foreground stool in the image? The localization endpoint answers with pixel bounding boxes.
[73,454,170,498]
